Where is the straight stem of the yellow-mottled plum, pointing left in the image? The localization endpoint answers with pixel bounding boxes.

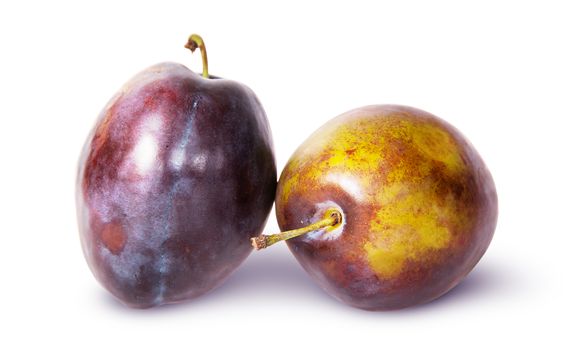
[250,208,343,250]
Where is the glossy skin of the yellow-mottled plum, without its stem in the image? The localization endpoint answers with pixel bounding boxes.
[276,105,498,310]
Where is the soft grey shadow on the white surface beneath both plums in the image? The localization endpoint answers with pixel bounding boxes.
[99,253,518,317]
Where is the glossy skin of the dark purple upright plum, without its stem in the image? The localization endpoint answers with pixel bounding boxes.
[76,63,276,308]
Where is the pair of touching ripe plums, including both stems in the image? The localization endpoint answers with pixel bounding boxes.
[77,35,497,310]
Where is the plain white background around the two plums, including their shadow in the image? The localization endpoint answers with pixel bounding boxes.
[0,0,571,349]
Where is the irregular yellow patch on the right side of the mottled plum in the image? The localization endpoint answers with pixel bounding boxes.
[363,121,469,278]
